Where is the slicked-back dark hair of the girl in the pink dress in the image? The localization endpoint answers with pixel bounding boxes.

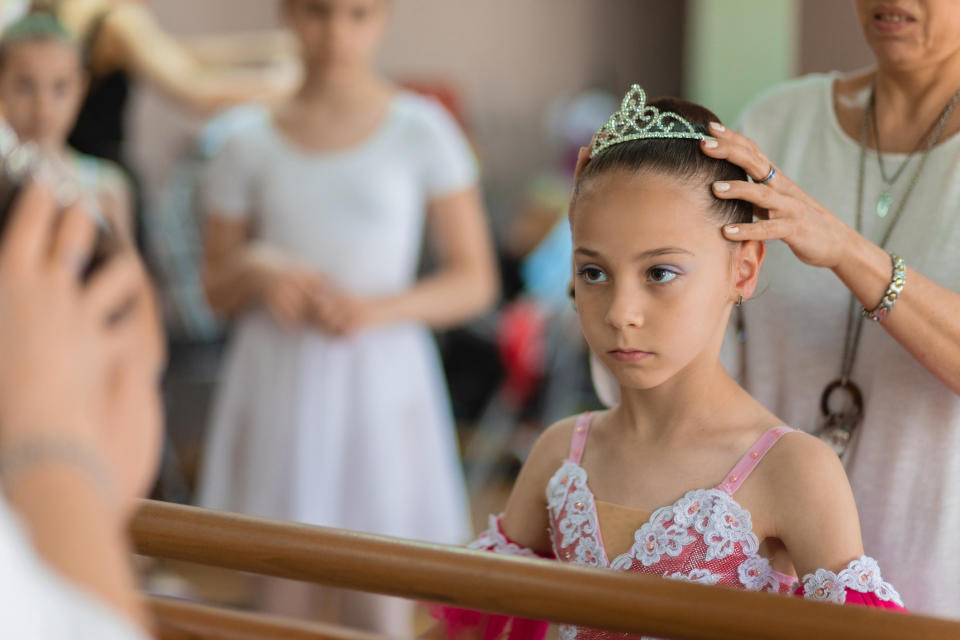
[570,98,753,224]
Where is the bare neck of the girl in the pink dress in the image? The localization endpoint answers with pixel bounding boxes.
[612,358,749,440]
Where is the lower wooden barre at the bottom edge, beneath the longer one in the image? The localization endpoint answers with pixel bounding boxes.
[147,597,385,640]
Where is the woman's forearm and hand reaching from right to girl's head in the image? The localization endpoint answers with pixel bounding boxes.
[701,123,960,394]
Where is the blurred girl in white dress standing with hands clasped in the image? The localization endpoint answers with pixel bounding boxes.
[200,0,496,635]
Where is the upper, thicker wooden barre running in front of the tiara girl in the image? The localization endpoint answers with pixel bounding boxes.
[132,501,960,640]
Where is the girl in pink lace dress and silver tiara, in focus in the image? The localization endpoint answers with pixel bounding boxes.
[435,86,902,640]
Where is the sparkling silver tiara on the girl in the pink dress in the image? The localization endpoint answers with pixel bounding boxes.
[590,84,712,158]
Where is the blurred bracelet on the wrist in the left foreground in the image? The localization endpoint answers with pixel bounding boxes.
[0,439,119,501]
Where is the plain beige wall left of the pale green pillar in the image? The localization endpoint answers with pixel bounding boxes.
[131,0,684,208]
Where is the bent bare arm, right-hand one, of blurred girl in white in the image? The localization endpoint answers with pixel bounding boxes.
[318,187,499,333]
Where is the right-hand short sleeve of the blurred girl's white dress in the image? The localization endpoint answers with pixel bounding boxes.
[417,98,478,200]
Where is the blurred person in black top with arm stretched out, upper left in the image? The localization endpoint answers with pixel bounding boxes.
[0,0,299,244]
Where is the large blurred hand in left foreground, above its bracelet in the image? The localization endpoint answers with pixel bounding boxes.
[0,185,164,508]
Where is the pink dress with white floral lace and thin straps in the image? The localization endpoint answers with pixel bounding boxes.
[434,414,903,640]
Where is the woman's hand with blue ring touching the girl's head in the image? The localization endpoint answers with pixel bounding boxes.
[700,123,856,269]
